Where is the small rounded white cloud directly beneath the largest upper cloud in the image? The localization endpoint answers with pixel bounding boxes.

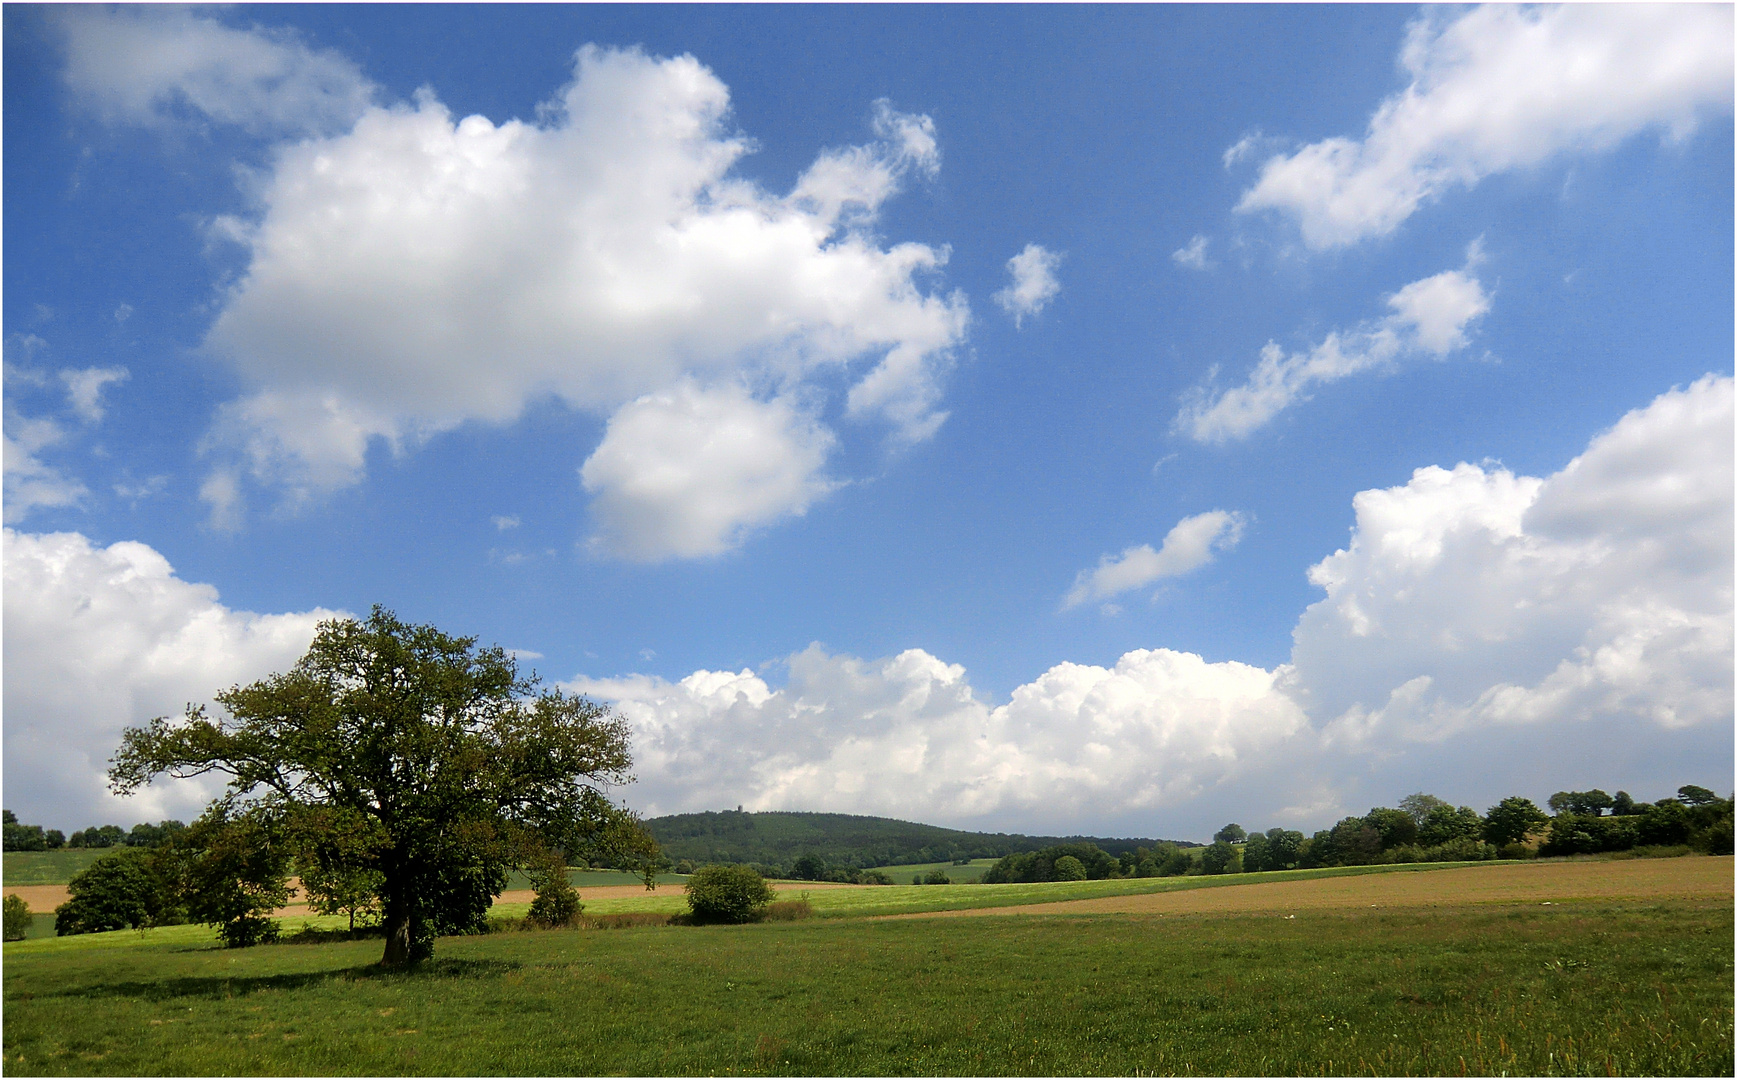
[580,384,835,559]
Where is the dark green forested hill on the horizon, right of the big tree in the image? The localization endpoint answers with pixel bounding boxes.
[646,811,1193,866]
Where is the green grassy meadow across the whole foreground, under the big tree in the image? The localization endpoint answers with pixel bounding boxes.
[3,887,1734,1077]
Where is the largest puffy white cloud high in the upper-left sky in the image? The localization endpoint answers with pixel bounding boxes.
[190,47,969,557]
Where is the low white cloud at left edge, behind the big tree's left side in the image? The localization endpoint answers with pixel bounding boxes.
[3,530,334,828]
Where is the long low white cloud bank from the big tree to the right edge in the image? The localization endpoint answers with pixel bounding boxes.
[573,377,1734,837]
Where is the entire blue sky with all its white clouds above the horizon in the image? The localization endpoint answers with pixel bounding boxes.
[3,5,1732,837]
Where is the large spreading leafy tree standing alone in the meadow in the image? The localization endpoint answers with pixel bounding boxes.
[109,606,644,965]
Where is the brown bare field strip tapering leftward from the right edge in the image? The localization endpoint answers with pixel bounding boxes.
[881,856,1734,919]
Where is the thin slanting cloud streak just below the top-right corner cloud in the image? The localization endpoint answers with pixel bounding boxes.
[1172,243,1490,443]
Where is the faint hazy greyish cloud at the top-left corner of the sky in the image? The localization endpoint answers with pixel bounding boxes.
[57,5,375,134]
